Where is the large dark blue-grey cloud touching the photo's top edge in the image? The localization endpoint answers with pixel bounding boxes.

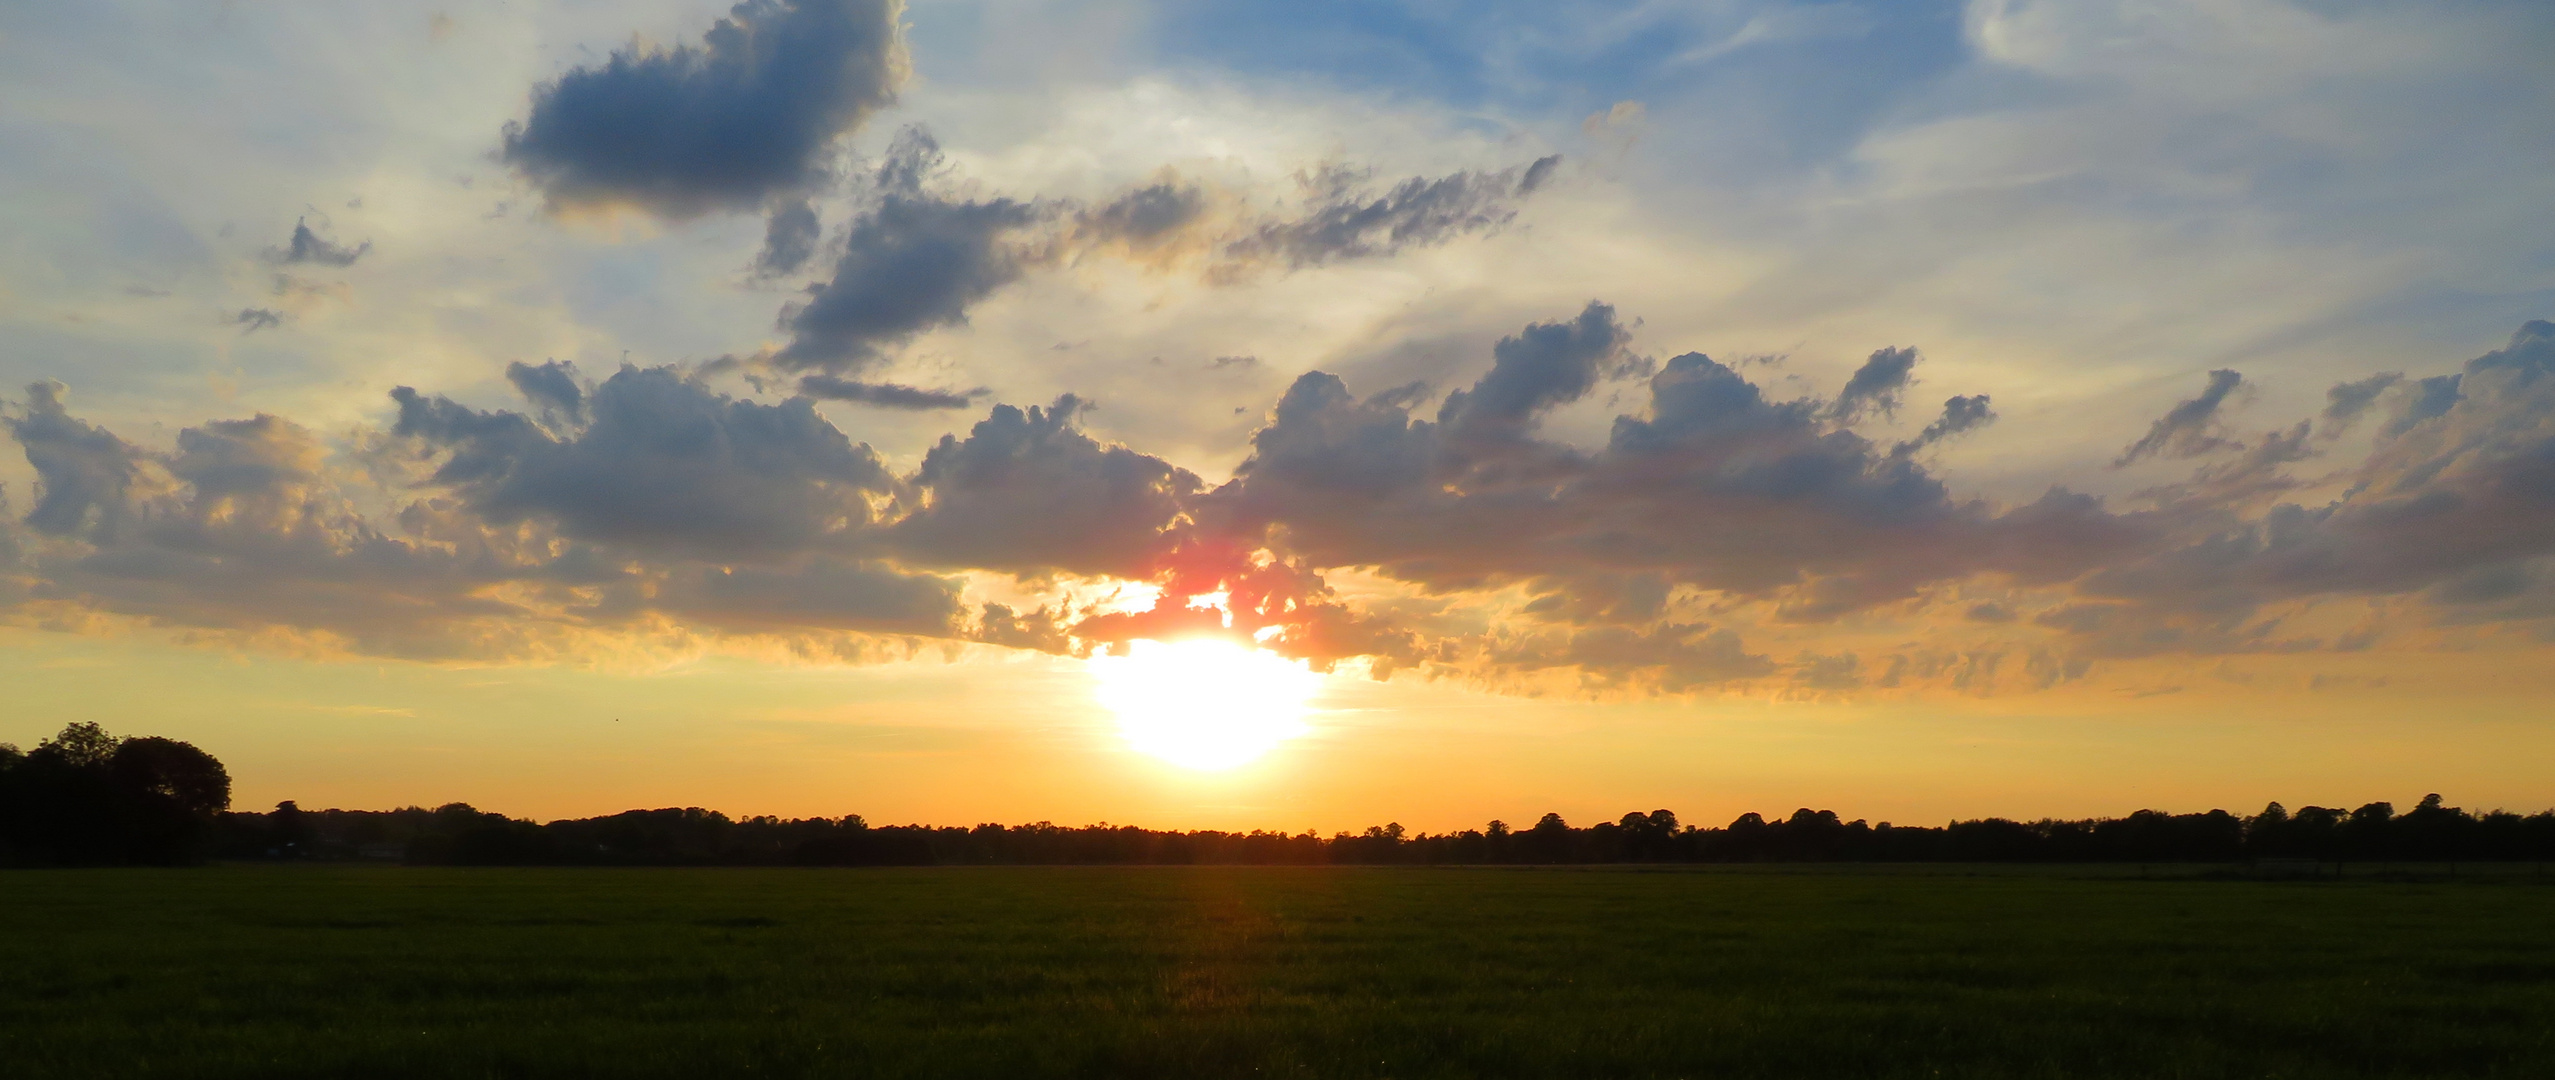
[503,0,907,217]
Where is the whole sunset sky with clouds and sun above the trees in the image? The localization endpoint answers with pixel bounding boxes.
[0,0,2555,832]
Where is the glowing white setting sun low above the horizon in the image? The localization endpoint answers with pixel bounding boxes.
[1091,638,1321,771]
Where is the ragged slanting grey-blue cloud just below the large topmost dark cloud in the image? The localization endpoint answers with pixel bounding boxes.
[772,130,1042,373]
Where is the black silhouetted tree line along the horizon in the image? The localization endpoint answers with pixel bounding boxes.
[0,725,2555,866]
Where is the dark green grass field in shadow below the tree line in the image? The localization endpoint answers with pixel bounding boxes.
[0,868,2555,1080]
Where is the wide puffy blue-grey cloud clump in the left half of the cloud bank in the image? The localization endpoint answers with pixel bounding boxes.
[391,368,894,559]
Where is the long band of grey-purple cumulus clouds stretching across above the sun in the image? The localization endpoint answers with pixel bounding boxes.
[19,304,2555,692]
